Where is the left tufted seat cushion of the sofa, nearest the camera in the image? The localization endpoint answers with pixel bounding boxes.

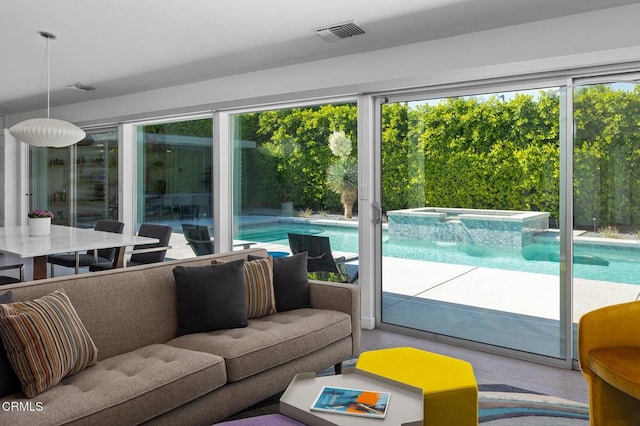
[0,344,226,425]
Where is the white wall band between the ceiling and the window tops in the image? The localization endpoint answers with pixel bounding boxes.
[7,5,640,127]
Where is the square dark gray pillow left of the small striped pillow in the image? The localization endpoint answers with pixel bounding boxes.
[173,260,249,336]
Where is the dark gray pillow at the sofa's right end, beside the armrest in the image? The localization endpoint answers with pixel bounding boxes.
[273,251,311,312]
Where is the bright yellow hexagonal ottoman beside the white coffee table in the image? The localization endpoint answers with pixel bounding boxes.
[356,348,478,426]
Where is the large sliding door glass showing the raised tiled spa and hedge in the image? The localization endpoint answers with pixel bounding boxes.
[380,86,567,358]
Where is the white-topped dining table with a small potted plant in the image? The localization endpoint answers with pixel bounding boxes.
[0,225,159,280]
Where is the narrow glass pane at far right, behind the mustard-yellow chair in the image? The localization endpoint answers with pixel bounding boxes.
[573,83,640,358]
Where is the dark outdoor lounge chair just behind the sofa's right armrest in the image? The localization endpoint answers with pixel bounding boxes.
[288,234,358,283]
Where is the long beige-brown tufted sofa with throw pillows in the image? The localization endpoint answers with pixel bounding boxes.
[0,249,360,426]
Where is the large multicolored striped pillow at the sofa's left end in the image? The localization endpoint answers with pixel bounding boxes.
[0,289,98,398]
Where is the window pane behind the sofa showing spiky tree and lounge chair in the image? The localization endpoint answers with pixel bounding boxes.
[232,104,358,280]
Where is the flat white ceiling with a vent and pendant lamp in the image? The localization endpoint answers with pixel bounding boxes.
[0,0,640,114]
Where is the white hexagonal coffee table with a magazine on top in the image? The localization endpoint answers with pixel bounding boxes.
[280,368,423,426]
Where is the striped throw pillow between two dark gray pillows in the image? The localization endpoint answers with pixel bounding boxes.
[244,257,276,319]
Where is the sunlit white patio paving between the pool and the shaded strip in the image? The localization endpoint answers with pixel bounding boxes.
[382,257,640,322]
